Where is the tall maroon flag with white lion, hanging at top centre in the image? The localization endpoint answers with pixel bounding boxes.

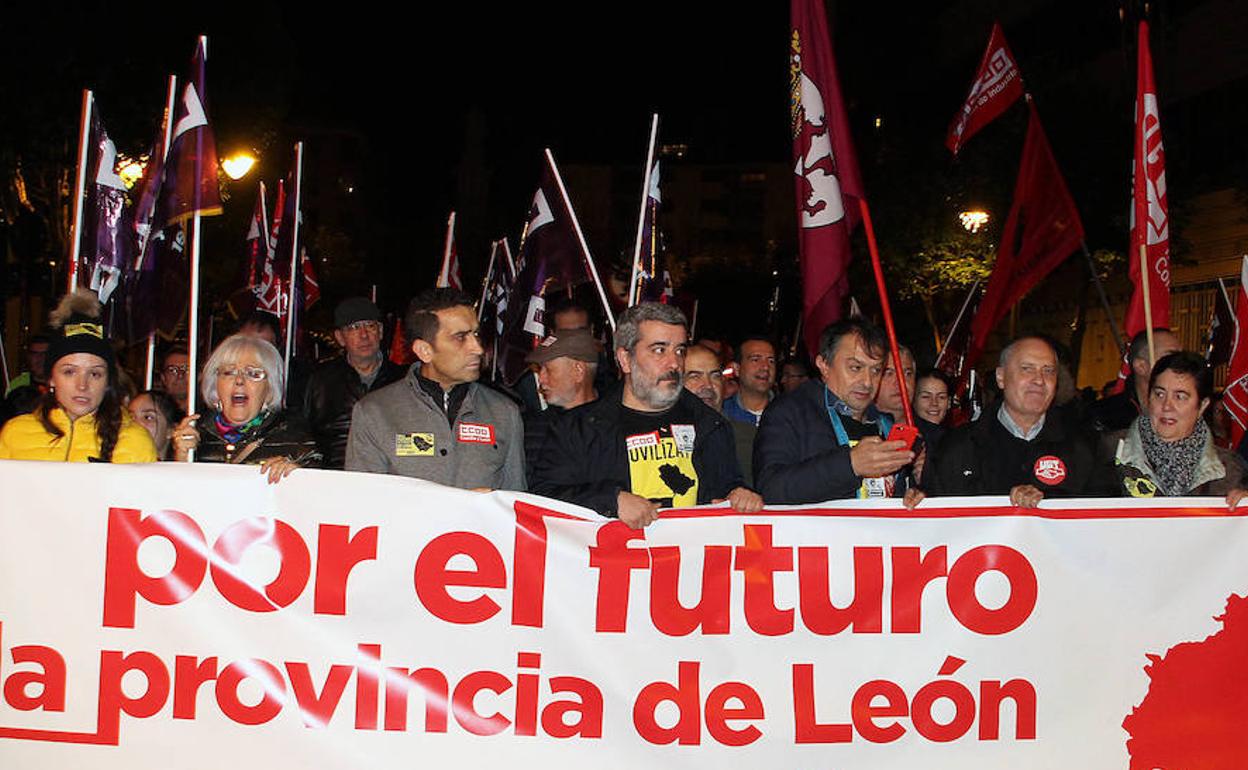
[789,0,865,356]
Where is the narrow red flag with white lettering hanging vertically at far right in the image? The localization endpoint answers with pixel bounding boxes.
[1126,21,1169,346]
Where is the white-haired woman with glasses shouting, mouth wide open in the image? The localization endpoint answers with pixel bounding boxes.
[173,333,321,483]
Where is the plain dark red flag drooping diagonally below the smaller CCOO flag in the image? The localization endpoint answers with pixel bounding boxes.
[966,102,1083,367]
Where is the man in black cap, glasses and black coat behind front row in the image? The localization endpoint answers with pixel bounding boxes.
[303,297,403,469]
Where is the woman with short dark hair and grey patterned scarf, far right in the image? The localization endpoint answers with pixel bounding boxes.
[1111,352,1248,508]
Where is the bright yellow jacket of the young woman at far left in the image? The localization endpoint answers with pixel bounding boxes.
[0,408,156,463]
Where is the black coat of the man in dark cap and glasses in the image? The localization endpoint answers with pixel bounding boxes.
[303,356,407,469]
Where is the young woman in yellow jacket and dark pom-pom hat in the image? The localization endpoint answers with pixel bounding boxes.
[0,292,156,463]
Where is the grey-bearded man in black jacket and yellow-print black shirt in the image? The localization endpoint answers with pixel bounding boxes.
[533,302,763,529]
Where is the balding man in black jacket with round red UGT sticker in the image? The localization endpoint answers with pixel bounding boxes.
[924,337,1116,508]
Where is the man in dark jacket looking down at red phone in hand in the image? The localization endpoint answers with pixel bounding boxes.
[754,318,921,507]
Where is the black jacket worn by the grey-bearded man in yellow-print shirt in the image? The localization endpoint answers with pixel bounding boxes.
[530,386,745,515]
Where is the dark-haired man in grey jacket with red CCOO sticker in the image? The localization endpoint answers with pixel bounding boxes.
[347,288,525,492]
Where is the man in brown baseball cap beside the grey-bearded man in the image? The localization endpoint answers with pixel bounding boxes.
[524,328,602,483]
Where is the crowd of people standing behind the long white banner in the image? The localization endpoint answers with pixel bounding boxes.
[0,288,1248,528]
